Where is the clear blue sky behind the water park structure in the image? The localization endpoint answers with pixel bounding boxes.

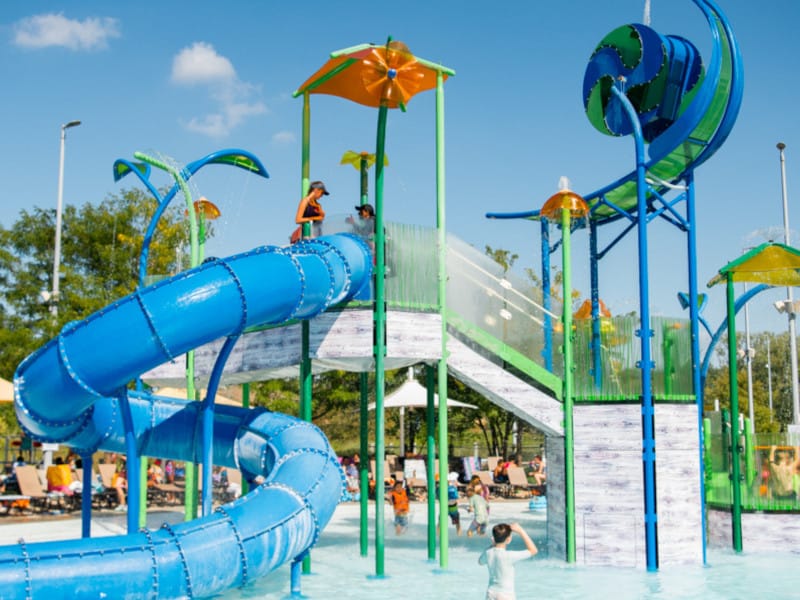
[0,0,800,344]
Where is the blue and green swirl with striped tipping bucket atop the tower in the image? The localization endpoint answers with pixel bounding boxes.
[583,0,743,222]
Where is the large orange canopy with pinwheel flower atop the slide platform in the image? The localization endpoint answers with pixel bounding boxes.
[294,41,451,108]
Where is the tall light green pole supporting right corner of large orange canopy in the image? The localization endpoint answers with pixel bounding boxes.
[436,71,450,569]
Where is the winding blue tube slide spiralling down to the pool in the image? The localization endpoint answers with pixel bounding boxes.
[0,234,372,599]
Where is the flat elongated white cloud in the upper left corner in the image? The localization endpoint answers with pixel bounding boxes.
[14,13,121,50]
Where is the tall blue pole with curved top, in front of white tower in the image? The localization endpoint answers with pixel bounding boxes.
[611,86,658,571]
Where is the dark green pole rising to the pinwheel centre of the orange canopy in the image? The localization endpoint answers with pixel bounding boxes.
[372,104,389,577]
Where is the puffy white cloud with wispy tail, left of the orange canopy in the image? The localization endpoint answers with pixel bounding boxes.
[171,42,268,138]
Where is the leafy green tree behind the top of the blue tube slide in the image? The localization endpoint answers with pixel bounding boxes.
[0,189,188,378]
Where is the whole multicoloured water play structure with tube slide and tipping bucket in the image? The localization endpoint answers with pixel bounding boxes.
[0,0,796,598]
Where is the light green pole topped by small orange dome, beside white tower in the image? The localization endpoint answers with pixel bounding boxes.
[561,208,575,563]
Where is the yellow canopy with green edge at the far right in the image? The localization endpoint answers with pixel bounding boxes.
[708,242,800,287]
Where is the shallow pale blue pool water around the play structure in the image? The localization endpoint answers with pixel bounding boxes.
[216,501,800,600]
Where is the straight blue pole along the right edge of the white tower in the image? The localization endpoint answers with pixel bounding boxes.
[686,170,707,564]
